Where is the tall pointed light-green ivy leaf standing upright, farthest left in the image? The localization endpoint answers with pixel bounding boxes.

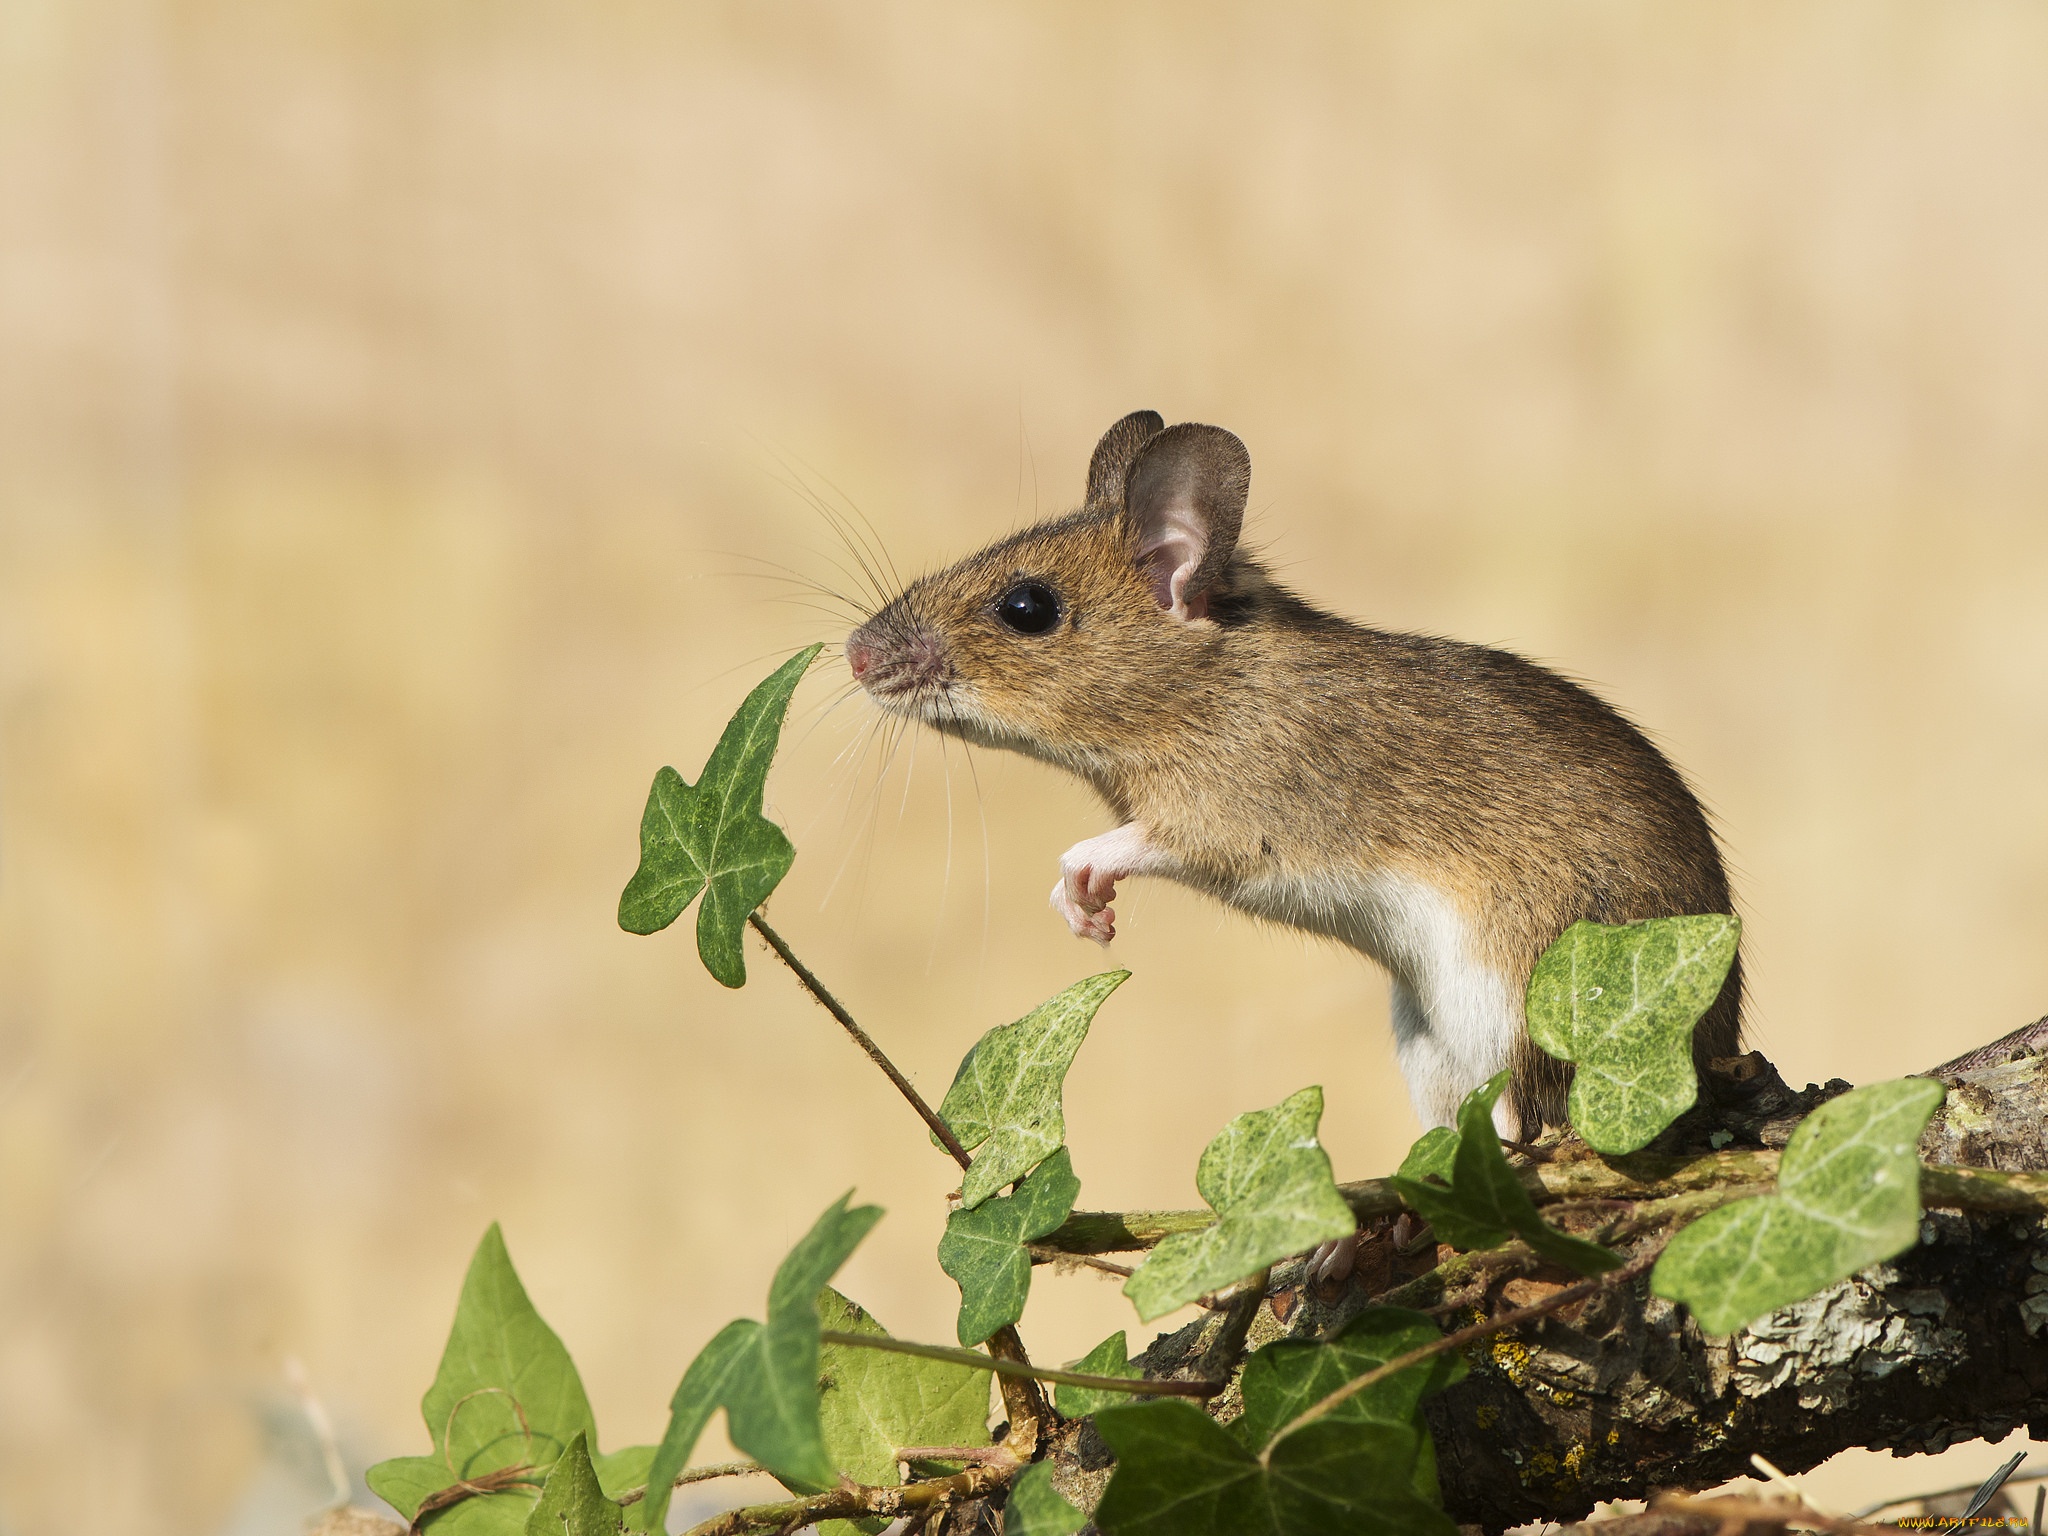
[367,1223,598,1536]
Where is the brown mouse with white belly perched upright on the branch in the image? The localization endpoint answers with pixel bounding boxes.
[846,410,1743,1141]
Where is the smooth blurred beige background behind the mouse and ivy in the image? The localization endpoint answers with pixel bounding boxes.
[0,0,2048,1536]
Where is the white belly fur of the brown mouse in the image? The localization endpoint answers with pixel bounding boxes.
[1225,870,1522,1133]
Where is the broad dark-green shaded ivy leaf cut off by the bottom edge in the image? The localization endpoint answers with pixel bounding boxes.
[1096,1399,1458,1536]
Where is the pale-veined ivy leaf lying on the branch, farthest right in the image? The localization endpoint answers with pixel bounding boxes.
[1651,1077,1944,1333]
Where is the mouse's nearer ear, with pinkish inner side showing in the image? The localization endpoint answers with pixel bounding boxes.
[1124,422,1251,621]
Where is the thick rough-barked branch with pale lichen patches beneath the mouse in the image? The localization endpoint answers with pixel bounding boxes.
[1425,1040,2048,1530]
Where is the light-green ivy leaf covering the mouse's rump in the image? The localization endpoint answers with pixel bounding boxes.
[1528,913,1743,1153]
